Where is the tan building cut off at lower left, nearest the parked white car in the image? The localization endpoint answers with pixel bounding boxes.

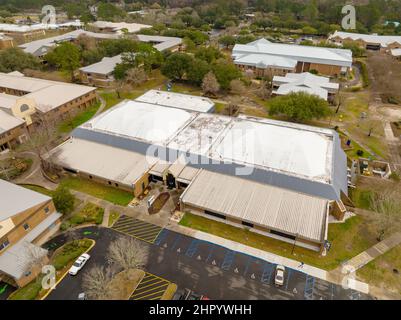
[0,180,61,287]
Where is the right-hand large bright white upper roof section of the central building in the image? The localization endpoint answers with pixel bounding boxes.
[213,120,333,183]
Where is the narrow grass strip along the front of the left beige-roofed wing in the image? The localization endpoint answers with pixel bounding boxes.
[61,177,134,206]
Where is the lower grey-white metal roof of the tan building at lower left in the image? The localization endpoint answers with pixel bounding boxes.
[0,212,62,279]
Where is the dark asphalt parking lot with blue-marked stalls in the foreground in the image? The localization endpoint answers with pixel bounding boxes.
[43,227,370,300]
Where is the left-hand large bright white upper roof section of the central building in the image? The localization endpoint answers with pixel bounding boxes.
[83,100,195,145]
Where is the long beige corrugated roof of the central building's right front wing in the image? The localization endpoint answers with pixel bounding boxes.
[181,170,328,242]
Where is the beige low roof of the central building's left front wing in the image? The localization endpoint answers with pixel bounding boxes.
[50,138,158,186]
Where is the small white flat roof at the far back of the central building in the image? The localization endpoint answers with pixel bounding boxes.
[135,90,214,112]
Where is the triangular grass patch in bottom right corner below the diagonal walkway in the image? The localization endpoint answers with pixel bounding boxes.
[357,245,401,294]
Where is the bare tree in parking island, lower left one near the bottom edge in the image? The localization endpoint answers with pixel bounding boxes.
[82,265,115,300]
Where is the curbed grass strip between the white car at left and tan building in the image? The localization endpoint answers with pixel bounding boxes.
[8,239,93,300]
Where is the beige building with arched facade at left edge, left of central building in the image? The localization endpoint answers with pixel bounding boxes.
[0,72,98,149]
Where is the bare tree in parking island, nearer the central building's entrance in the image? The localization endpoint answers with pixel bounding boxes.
[107,237,148,271]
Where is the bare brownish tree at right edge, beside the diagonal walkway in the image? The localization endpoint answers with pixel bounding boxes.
[369,188,401,241]
